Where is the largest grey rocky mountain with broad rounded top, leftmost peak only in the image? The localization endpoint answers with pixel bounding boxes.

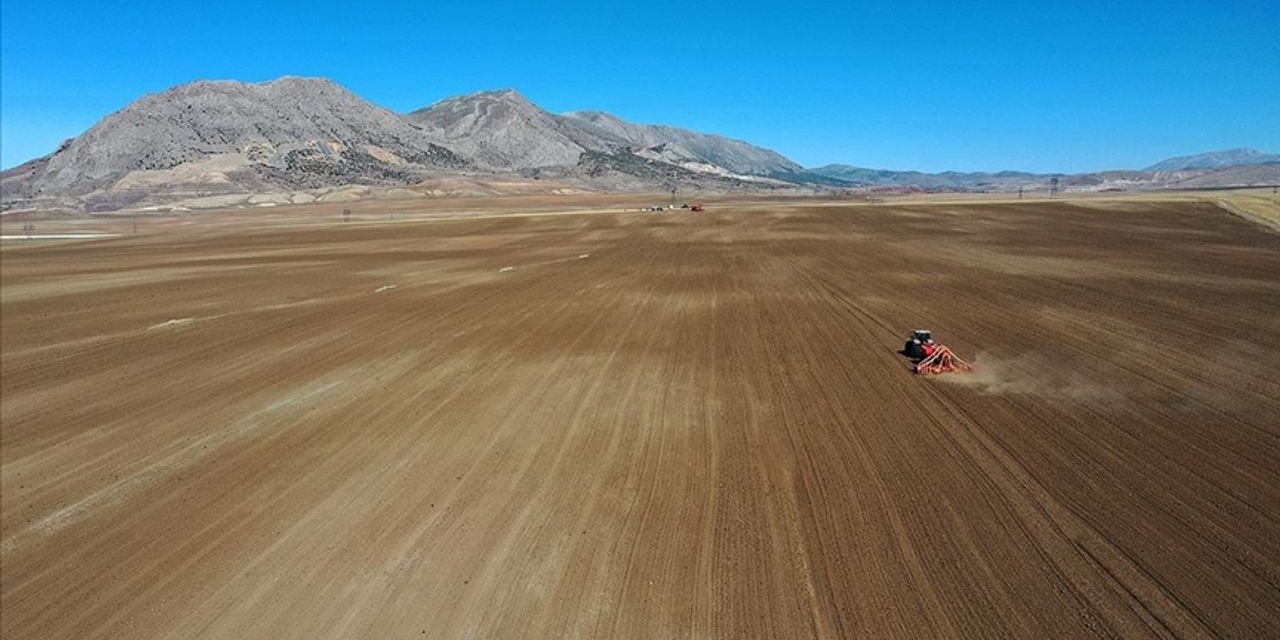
[4,77,467,210]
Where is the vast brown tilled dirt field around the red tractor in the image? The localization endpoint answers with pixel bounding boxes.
[0,197,1280,640]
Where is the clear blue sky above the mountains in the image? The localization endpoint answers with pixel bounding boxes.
[0,0,1280,172]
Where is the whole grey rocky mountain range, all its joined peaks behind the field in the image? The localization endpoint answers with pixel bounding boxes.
[0,77,800,211]
